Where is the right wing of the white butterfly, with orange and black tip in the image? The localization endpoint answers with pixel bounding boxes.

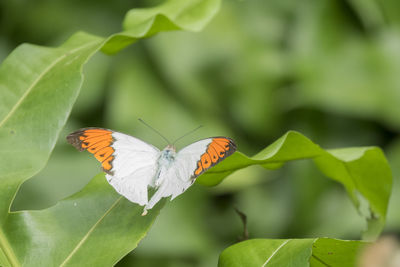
[145,137,236,209]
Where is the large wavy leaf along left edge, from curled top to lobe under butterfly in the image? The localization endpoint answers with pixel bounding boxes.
[0,0,220,266]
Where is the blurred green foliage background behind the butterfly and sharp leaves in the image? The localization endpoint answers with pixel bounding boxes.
[0,0,400,266]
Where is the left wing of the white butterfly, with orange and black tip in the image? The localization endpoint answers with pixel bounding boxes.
[67,128,160,205]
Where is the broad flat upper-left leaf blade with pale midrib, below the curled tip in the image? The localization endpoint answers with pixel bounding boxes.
[0,33,102,223]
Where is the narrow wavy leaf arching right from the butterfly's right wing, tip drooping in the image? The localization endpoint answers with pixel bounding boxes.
[197,131,392,239]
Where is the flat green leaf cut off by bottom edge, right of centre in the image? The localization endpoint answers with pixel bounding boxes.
[218,238,367,267]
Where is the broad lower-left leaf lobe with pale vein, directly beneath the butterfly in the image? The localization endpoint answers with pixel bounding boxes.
[4,174,165,266]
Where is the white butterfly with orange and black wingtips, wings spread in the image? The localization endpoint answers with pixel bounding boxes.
[67,128,236,215]
